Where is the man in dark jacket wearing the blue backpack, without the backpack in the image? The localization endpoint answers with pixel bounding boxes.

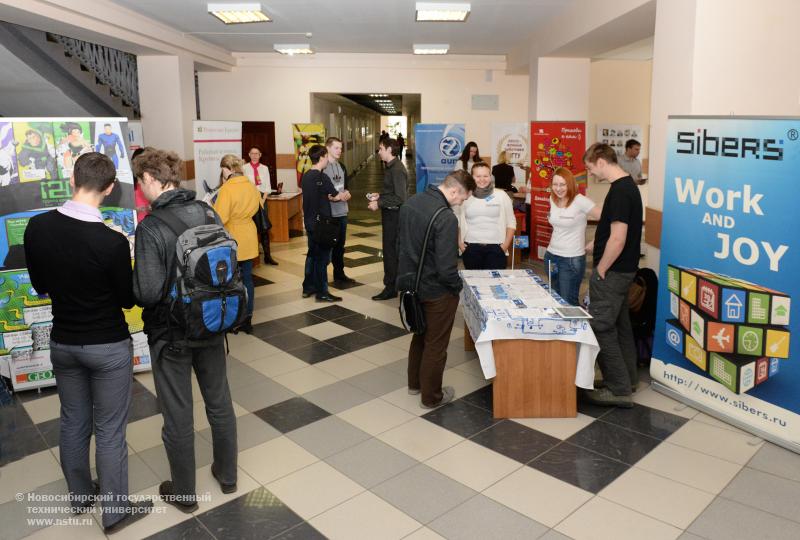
[133,148,238,513]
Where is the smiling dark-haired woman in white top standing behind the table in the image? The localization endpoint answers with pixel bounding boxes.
[458,162,517,270]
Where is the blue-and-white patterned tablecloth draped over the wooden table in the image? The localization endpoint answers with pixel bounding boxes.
[461,270,600,389]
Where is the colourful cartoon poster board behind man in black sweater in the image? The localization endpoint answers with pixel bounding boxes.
[0,118,150,390]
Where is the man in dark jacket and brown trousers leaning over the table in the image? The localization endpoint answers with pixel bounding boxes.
[397,171,475,409]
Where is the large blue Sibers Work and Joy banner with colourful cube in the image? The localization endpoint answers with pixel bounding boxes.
[650,117,800,452]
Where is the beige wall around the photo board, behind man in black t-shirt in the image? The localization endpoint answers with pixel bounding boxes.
[586,60,653,204]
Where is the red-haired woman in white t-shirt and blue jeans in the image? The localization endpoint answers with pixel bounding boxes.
[544,167,601,306]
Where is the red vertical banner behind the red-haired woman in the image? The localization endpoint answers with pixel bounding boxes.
[530,121,586,259]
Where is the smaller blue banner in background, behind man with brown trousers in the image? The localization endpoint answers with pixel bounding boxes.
[414,124,464,193]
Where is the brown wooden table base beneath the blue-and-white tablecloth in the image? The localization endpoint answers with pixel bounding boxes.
[464,324,578,418]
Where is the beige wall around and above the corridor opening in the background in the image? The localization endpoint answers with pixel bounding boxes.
[199,54,528,185]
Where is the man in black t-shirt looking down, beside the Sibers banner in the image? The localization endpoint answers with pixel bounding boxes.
[583,143,642,408]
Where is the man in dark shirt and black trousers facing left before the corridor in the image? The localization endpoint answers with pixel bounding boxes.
[368,138,408,300]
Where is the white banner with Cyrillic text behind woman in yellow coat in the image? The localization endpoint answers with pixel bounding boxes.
[192,120,242,199]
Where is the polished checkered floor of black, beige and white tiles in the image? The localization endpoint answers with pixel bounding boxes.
[0,154,800,540]
